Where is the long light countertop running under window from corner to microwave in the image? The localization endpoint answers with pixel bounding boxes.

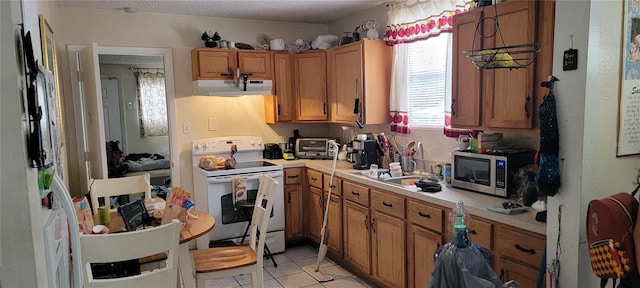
[268,159,547,235]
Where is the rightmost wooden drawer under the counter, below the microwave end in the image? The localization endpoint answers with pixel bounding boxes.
[496,226,546,266]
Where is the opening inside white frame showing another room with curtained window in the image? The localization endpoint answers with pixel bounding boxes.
[98,53,171,186]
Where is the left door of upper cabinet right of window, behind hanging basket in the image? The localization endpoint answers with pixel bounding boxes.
[451,9,480,128]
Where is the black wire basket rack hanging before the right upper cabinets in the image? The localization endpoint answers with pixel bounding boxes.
[462,5,541,69]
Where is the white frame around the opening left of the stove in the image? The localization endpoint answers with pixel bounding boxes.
[67,45,181,191]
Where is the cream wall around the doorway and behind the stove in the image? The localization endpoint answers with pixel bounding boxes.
[55,7,327,194]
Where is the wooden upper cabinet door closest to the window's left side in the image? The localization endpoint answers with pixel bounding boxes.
[330,43,362,122]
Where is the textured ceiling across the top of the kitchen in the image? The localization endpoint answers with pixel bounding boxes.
[55,0,389,24]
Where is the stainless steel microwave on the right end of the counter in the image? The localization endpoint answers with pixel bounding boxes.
[451,151,535,198]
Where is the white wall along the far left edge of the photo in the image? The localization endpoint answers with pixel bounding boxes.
[0,1,51,287]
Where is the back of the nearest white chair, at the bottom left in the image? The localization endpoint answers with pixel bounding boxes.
[80,219,181,288]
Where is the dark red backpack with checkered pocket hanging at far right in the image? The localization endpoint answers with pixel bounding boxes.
[586,189,640,287]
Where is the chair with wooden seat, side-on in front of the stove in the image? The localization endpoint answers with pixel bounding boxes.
[193,175,278,287]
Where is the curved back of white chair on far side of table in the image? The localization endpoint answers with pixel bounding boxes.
[89,174,151,215]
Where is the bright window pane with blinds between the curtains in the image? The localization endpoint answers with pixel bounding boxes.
[408,34,451,128]
